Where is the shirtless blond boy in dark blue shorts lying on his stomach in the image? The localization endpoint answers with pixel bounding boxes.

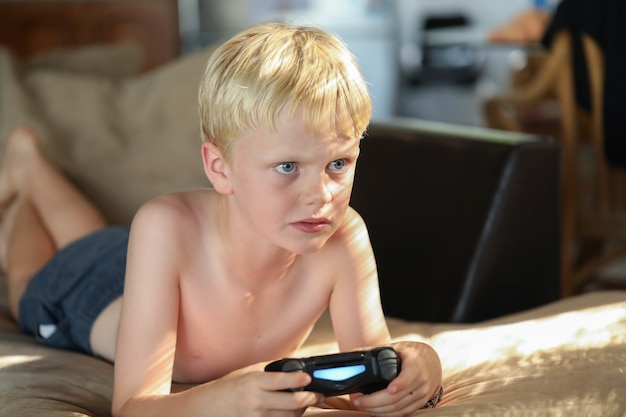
[0,24,441,417]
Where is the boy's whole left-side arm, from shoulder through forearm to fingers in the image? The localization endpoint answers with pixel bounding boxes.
[112,199,321,417]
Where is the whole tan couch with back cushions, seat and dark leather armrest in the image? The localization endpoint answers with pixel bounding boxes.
[0,45,626,417]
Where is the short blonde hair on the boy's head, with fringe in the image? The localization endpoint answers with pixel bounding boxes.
[199,23,372,156]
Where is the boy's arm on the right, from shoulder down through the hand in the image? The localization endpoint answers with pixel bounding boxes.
[330,208,442,416]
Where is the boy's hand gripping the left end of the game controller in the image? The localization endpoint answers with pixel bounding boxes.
[197,364,324,417]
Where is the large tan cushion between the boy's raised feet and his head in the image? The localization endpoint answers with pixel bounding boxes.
[0,44,216,223]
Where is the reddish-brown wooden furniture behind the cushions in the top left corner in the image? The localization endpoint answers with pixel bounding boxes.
[0,0,180,70]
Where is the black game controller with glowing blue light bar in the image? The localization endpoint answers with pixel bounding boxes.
[265,346,401,397]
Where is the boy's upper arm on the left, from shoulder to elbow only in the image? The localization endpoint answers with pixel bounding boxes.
[113,197,179,415]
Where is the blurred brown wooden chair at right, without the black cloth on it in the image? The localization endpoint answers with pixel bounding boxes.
[485,30,626,296]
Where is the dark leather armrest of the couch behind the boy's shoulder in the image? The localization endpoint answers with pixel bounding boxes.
[351,119,559,322]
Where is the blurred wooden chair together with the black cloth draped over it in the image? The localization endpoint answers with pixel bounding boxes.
[484,0,626,296]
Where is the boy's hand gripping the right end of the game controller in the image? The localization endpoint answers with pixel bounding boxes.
[353,342,442,417]
